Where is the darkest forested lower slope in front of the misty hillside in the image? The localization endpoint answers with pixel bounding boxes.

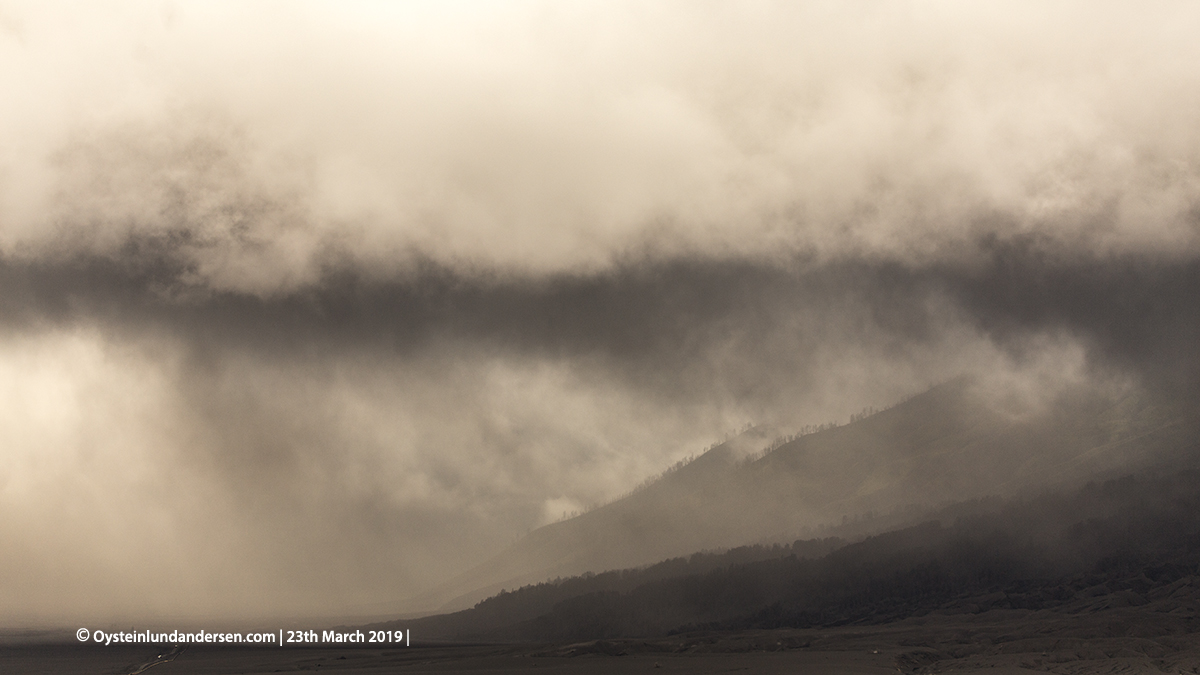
[381,471,1200,640]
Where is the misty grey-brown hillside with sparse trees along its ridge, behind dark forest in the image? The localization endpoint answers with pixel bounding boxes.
[403,380,1195,610]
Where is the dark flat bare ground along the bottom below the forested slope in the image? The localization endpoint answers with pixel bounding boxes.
[7,595,1200,675]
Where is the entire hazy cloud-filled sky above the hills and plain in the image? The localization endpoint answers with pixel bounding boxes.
[0,0,1200,621]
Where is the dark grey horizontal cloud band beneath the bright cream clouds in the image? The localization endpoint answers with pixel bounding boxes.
[0,233,1200,396]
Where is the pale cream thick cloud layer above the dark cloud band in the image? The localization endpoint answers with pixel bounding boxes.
[0,2,1200,283]
